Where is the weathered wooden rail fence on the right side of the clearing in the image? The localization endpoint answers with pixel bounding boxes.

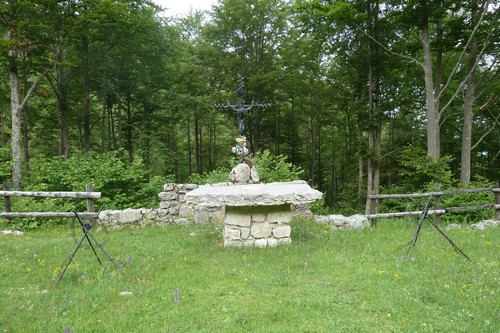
[366,186,500,225]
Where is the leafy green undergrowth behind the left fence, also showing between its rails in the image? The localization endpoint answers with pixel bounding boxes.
[2,153,174,229]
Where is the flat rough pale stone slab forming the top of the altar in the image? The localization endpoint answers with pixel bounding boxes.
[186,181,323,206]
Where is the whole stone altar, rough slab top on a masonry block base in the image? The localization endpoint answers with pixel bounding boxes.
[186,181,322,247]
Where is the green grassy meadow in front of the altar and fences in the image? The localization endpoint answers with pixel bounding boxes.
[0,220,500,332]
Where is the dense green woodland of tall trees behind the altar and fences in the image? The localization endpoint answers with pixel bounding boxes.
[0,0,500,212]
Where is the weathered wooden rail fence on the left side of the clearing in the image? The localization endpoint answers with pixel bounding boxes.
[0,184,101,218]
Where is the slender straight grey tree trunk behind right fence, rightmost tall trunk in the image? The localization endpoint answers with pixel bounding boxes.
[460,0,479,184]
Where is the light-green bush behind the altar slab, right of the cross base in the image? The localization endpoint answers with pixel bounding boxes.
[254,149,302,183]
